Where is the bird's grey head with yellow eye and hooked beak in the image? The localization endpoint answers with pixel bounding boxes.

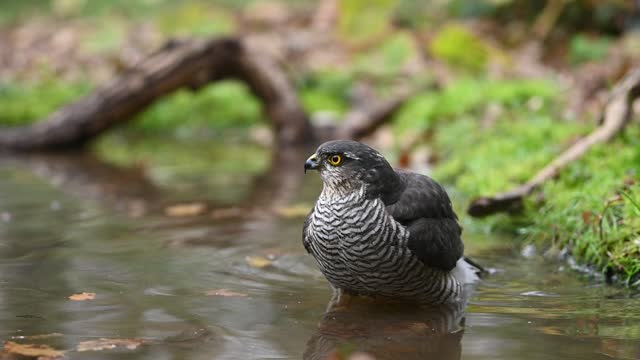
[304,140,400,198]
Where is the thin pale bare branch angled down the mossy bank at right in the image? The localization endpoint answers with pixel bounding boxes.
[467,69,640,217]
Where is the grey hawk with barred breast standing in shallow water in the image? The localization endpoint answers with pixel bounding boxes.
[302,140,484,305]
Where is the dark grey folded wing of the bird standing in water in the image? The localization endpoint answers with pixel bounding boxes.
[386,171,464,271]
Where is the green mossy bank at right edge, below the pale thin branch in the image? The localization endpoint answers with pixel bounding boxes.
[530,140,640,281]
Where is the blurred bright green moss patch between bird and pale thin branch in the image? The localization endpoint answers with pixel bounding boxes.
[436,113,587,195]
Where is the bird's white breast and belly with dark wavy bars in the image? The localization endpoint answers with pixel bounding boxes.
[304,189,462,304]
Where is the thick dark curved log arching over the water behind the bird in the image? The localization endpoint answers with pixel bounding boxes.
[0,38,313,151]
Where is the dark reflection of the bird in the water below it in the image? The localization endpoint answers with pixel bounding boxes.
[304,298,465,360]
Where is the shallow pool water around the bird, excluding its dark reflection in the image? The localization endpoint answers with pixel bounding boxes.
[0,139,640,359]
